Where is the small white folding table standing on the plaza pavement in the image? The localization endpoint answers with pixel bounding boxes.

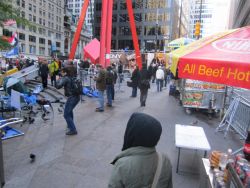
[175,124,211,173]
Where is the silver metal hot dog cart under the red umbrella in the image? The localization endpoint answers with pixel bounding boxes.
[180,79,226,114]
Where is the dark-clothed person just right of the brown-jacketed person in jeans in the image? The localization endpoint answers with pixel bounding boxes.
[106,66,115,107]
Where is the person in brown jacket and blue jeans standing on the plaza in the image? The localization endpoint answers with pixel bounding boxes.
[94,64,106,112]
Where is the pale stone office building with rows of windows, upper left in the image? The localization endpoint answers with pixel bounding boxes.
[10,0,64,57]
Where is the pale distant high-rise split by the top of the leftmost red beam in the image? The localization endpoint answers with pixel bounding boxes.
[66,0,94,36]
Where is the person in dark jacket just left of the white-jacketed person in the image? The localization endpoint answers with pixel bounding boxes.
[138,64,150,106]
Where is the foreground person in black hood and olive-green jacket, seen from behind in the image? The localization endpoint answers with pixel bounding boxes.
[108,113,173,188]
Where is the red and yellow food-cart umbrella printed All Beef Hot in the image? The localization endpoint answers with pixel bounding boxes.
[168,26,250,89]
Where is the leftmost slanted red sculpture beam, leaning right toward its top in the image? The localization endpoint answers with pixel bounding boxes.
[69,0,89,59]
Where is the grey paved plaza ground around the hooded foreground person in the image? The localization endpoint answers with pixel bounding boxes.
[0,83,242,188]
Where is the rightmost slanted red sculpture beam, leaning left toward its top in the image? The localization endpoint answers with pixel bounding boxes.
[126,0,142,68]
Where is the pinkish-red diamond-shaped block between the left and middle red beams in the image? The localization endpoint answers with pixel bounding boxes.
[83,39,100,64]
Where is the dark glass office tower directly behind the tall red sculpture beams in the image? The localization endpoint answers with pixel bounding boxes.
[94,0,178,51]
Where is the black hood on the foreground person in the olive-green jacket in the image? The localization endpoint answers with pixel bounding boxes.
[122,113,162,151]
